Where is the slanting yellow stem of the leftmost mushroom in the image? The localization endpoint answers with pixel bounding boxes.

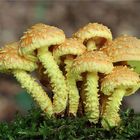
[13,70,53,117]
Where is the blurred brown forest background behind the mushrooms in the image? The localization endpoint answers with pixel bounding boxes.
[0,0,140,121]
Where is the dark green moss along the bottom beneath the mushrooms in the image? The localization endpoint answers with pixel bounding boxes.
[0,109,140,140]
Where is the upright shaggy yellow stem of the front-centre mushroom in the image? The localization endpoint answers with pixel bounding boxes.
[84,72,99,123]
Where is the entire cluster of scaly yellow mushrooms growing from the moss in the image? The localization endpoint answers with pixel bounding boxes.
[0,23,140,129]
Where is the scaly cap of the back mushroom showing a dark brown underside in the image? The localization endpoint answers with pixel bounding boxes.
[73,23,112,42]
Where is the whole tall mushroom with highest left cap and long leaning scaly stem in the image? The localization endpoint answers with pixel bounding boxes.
[20,23,68,114]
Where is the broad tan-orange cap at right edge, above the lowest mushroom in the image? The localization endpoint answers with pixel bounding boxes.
[100,35,140,62]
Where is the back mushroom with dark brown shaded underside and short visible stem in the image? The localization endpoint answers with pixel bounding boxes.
[73,23,112,51]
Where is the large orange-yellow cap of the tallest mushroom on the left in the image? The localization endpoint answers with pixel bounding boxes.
[20,23,65,54]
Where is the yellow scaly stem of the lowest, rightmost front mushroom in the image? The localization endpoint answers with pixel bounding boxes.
[101,88,125,129]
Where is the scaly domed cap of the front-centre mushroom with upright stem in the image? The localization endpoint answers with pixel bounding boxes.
[71,51,113,74]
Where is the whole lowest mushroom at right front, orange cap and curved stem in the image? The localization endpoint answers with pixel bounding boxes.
[101,66,140,129]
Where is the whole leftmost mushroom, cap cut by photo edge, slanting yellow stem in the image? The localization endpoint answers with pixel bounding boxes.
[0,42,53,116]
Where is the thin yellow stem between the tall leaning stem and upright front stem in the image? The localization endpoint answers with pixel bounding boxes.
[66,71,80,116]
